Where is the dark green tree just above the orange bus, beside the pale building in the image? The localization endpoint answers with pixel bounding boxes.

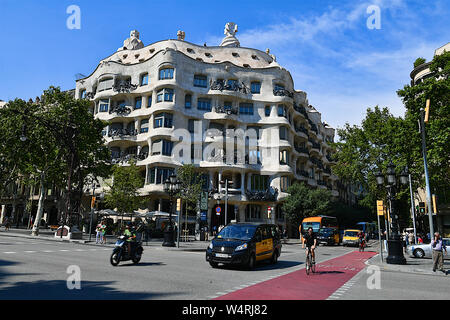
[283,183,332,226]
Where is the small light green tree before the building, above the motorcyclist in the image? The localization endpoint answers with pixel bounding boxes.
[105,161,144,229]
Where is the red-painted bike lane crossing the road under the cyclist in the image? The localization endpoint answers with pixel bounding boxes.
[214,251,376,300]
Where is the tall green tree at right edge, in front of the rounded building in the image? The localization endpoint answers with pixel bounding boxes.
[397,52,450,203]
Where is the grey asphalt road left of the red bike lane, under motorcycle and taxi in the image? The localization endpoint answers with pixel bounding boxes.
[0,235,353,300]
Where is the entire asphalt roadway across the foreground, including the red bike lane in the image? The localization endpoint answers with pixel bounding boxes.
[0,235,450,300]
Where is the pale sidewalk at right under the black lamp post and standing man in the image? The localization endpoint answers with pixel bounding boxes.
[366,250,450,277]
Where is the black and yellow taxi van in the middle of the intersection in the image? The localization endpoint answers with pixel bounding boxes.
[206,223,282,269]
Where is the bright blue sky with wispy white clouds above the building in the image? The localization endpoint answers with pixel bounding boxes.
[0,0,450,127]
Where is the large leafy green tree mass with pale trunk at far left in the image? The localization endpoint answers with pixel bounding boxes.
[0,87,110,234]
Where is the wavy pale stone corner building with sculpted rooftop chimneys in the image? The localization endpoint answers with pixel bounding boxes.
[75,23,339,236]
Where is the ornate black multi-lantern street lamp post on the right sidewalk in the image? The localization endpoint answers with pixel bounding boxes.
[375,161,408,264]
